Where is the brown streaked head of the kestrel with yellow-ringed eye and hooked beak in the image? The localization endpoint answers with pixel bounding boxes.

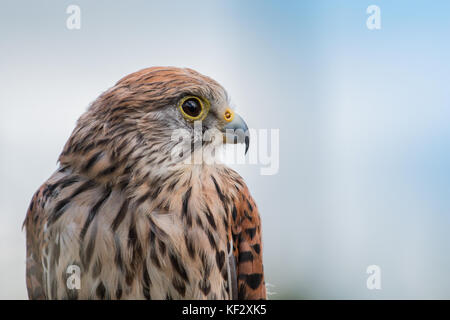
[59,67,249,181]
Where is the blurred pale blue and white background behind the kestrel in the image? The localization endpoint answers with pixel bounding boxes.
[0,0,450,299]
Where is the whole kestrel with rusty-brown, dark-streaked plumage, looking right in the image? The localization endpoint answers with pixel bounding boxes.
[24,67,266,299]
